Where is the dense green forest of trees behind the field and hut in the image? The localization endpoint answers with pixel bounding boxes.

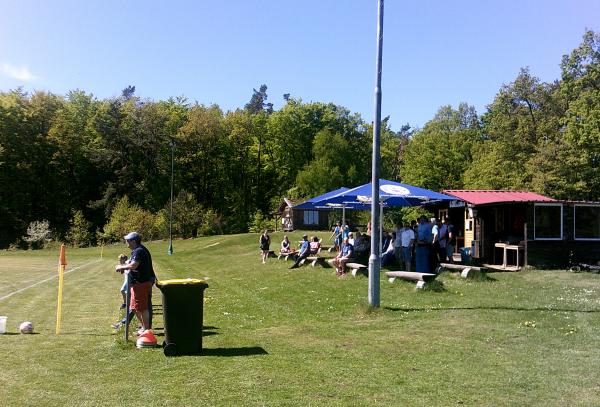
[0,31,600,248]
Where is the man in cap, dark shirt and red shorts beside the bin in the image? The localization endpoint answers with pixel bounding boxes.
[115,232,156,334]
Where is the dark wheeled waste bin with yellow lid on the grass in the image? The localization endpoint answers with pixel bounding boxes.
[156,278,208,356]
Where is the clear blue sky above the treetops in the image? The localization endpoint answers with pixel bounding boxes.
[0,0,600,130]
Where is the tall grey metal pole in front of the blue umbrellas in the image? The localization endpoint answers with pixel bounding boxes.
[369,0,383,307]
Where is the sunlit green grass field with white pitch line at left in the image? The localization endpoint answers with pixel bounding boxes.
[0,233,600,406]
